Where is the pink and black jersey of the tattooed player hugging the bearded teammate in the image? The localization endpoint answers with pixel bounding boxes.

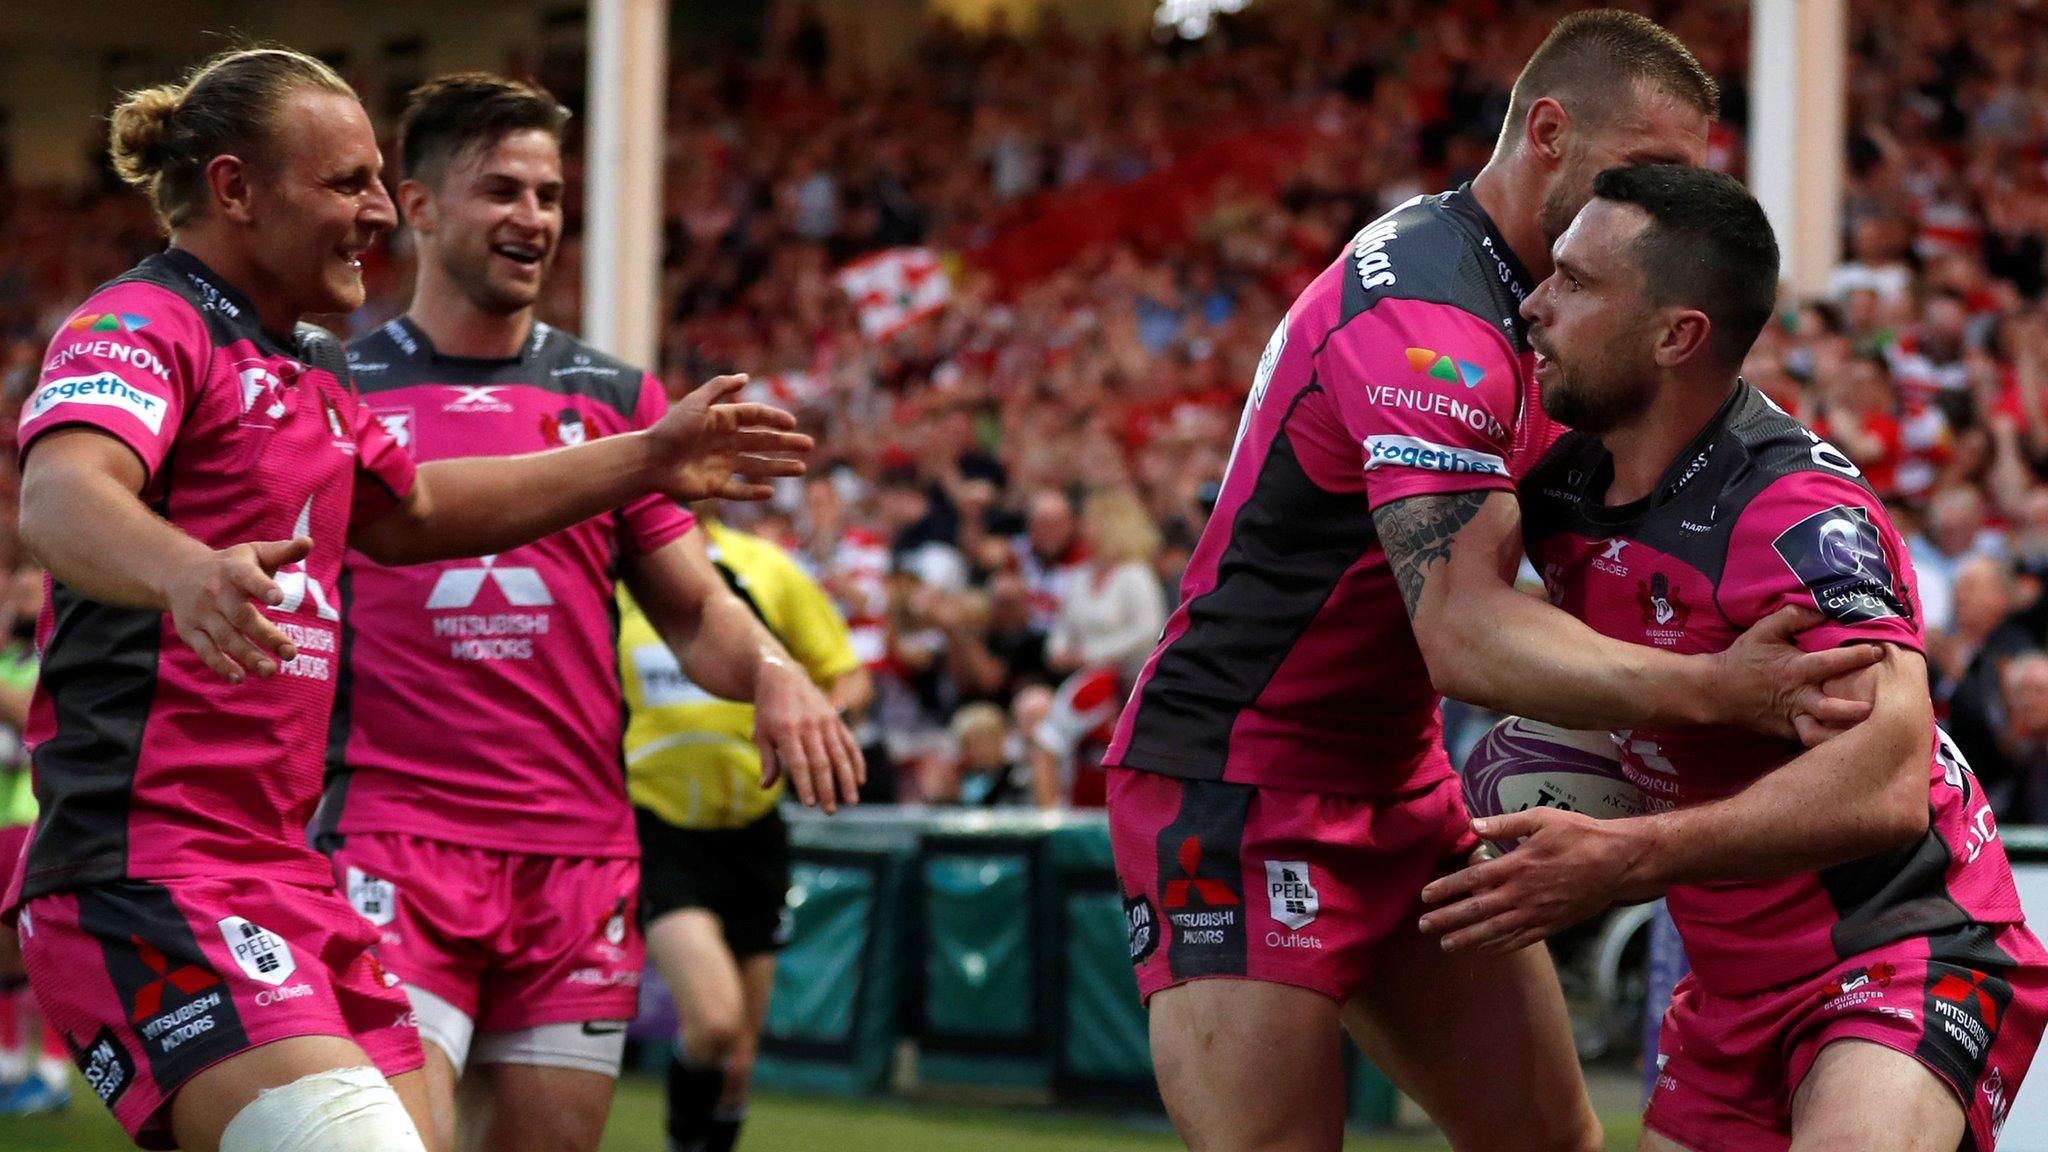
[1106,187,1548,795]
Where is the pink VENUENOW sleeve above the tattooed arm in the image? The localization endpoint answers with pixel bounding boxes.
[1315,299,1522,508]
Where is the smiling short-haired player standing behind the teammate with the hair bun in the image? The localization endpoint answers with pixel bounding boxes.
[315,72,860,1152]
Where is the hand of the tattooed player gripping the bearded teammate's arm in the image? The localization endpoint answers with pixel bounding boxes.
[1714,605,1884,746]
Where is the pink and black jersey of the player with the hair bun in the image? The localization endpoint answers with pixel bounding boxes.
[14,250,414,900]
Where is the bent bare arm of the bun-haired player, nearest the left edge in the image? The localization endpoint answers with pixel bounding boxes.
[20,426,313,683]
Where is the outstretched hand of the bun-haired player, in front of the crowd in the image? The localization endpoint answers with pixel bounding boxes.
[647,375,811,502]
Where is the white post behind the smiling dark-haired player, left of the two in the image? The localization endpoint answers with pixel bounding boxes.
[584,0,670,362]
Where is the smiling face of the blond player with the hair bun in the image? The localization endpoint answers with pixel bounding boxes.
[246,88,397,314]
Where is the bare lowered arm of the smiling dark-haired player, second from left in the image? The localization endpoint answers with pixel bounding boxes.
[627,529,868,814]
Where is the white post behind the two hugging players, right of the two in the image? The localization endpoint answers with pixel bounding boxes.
[1749,0,1847,295]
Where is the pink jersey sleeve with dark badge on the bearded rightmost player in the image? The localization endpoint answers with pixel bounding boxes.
[1720,463,1923,652]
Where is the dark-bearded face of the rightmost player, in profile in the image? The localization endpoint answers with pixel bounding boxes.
[1522,201,1659,435]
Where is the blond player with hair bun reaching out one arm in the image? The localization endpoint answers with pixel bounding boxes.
[6,49,809,1152]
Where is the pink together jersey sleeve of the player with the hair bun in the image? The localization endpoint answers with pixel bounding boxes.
[20,281,201,480]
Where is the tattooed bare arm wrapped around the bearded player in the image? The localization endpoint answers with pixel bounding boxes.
[1372,490,1876,736]
